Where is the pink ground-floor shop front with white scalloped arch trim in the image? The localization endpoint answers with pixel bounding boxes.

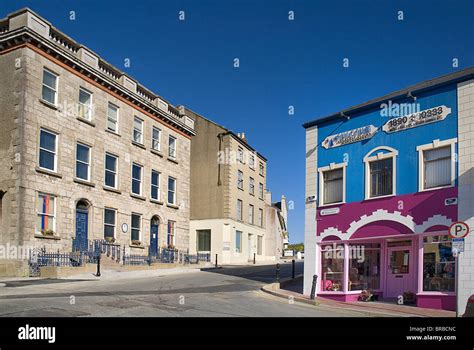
[316,187,457,310]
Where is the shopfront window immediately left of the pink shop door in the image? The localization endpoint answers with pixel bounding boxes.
[348,243,380,291]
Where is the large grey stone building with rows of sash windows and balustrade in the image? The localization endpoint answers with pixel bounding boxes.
[0,9,194,260]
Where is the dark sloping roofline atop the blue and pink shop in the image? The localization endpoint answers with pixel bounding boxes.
[303,67,474,129]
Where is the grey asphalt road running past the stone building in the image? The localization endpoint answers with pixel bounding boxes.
[0,263,363,317]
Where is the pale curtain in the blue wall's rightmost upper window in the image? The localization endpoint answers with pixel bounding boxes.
[423,146,451,189]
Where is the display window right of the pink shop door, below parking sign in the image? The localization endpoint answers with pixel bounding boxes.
[423,235,456,292]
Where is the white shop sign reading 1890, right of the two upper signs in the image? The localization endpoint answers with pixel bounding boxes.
[382,105,451,133]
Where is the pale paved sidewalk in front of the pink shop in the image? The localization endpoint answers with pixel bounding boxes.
[262,275,456,317]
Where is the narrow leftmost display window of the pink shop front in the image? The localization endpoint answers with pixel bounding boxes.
[321,245,344,292]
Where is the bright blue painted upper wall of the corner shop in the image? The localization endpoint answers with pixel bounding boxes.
[317,84,458,203]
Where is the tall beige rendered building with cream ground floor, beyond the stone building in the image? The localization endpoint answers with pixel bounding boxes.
[185,109,267,264]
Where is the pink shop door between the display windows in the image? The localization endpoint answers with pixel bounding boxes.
[384,241,416,299]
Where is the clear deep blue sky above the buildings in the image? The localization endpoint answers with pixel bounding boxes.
[0,0,474,242]
